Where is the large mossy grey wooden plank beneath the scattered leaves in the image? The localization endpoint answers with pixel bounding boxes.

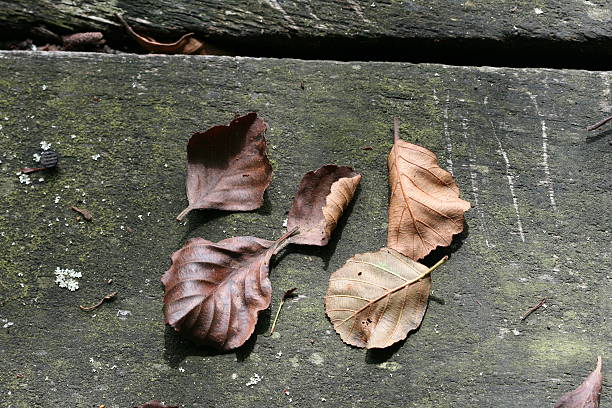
[0,53,612,407]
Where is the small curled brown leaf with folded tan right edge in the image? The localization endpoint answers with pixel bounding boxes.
[287,164,361,246]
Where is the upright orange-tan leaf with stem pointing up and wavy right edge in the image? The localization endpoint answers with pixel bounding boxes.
[387,121,470,260]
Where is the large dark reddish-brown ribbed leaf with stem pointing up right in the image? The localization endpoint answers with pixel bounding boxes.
[161,230,295,350]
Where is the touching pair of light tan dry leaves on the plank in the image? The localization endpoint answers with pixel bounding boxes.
[325,121,470,349]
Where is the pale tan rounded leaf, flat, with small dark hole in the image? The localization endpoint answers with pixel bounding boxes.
[325,248,446,349]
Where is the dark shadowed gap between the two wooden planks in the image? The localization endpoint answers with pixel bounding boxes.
[0,27,612,71]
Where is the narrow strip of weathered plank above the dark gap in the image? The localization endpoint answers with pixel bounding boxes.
[0,0,612,45]
